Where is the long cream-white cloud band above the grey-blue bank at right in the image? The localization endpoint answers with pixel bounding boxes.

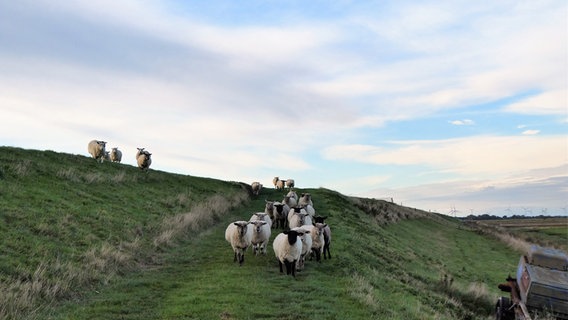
[322,135,566,177]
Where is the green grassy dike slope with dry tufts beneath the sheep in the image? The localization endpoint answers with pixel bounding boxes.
[0,147,532,319]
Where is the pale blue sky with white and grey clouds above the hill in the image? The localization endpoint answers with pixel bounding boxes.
[0,0,568,216]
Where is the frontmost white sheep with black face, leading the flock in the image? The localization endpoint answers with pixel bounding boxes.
[272,230,306,277]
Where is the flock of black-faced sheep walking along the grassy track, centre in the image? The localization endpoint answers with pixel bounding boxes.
[225,177,331,277]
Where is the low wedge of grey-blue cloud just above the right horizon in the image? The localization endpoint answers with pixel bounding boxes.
[365,165,568,216]
